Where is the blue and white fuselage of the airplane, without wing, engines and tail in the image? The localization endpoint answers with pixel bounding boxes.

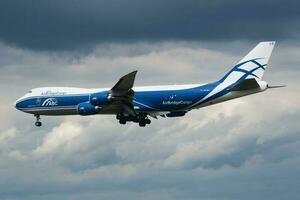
[15,82,266,115]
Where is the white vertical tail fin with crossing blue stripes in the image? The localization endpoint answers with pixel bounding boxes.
[219,41,275,84]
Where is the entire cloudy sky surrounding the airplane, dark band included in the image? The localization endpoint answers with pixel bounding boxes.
[0,0,300,200]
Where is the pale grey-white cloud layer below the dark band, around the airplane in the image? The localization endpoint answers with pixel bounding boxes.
[0,42,300,199]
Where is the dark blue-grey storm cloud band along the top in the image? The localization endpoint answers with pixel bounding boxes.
[0,0,300,50]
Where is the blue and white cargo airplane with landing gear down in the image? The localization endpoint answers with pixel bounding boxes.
[15,41,284,127]
